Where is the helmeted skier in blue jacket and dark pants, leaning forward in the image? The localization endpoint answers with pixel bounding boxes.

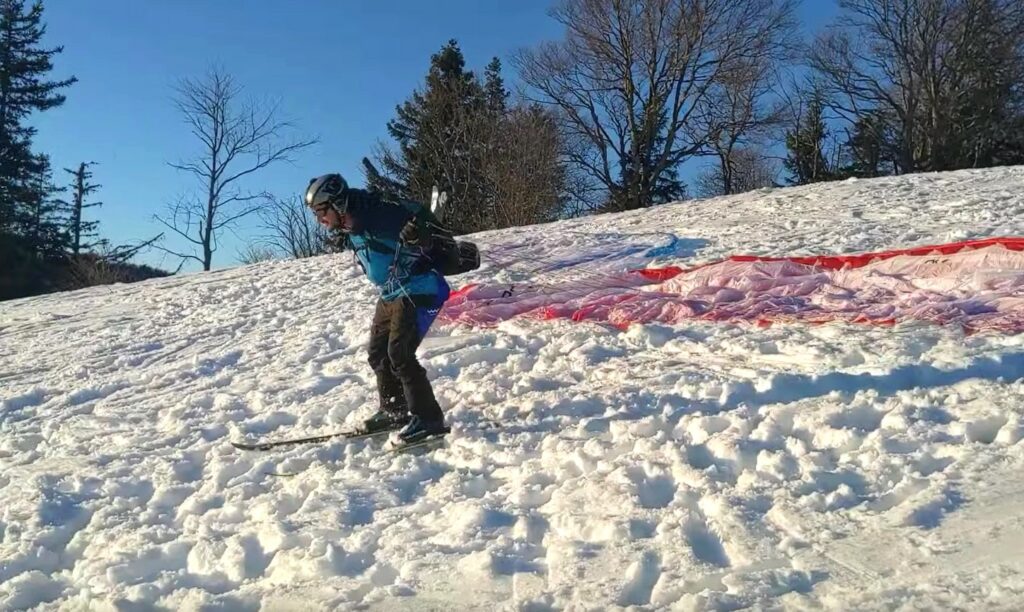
[305,174,451,444]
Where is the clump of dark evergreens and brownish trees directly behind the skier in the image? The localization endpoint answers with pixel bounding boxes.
[374,40,568,234]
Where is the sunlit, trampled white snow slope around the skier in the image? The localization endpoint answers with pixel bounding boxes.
[0,168,1024,610]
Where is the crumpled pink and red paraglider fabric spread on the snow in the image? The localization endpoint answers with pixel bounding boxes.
[440,237,1024,334]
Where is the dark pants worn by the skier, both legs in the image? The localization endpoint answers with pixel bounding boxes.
[368,297,444,421]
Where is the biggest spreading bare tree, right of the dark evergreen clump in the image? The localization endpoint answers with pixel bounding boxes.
[516,0,794,208]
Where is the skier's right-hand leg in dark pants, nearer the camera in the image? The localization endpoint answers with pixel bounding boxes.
[387,298,444,422]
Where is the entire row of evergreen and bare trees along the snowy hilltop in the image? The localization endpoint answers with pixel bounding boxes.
[0,0,1024,297]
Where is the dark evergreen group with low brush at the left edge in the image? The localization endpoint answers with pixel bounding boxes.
[0,0,166,300]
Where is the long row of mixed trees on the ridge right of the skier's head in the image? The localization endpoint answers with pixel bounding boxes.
[350,0,1024,242]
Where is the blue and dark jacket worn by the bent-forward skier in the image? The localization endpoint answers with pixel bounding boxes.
[345,189,451,306]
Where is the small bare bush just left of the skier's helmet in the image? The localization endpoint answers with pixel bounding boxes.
[259,198,330,259]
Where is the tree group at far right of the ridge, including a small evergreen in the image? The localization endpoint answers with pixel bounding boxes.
[785,0,1024,183]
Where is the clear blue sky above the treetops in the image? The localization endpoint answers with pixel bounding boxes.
[33,0,836,270]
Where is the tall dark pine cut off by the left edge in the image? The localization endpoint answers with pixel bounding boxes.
[0,0,76,244]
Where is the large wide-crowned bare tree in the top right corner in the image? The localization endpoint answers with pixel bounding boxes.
[810,0,1024,172]
